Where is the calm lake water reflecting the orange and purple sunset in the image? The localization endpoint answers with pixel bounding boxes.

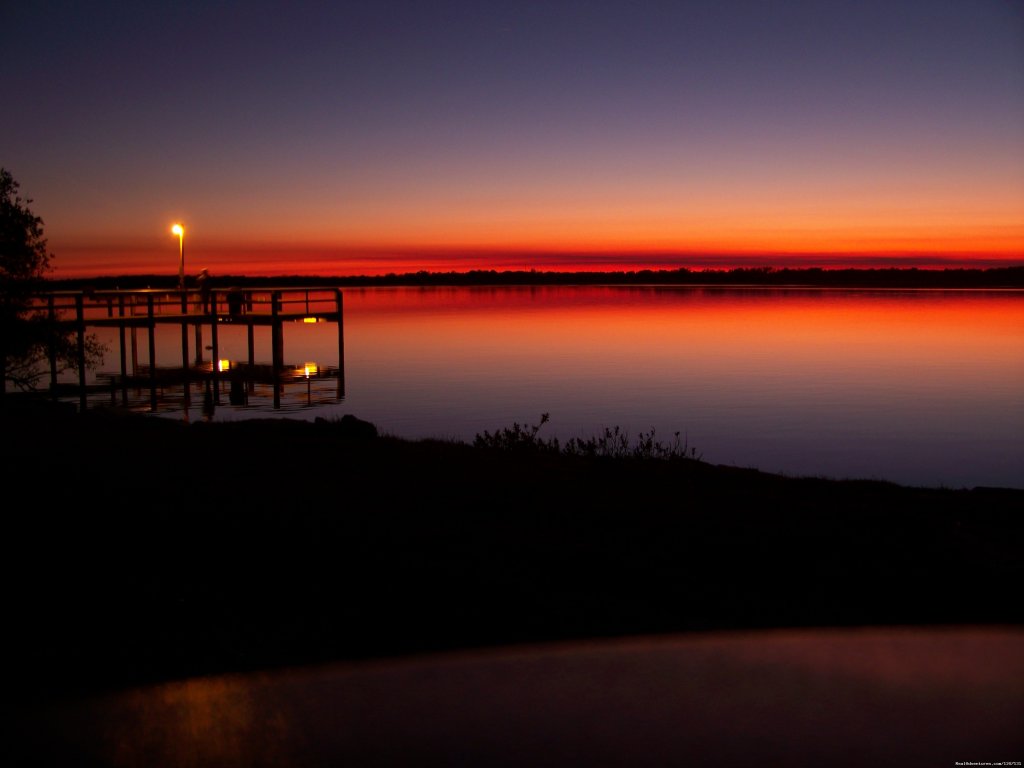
[83,286,1024,487]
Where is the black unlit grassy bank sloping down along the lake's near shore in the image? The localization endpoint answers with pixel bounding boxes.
[2,404,1024,708]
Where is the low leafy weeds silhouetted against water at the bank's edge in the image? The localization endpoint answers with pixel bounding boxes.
[473,414,703,461]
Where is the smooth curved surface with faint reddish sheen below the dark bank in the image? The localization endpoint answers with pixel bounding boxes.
[28,627,1024,768]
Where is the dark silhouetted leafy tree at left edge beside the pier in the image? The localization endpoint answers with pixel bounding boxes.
[0,168,102,397]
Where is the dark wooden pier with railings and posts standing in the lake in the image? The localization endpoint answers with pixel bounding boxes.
[28,287,345,411]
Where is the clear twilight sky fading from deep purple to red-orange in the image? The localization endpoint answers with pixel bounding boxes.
[0,0,1024,278]
